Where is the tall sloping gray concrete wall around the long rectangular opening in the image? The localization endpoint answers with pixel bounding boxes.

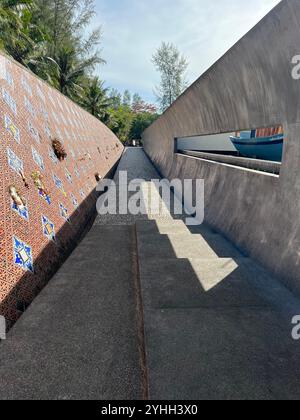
[143,0,300,292]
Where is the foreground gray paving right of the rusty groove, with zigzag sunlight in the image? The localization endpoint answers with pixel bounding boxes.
[136,220,300,400]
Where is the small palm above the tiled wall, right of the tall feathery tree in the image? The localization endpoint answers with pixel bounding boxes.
[82,77,112,121]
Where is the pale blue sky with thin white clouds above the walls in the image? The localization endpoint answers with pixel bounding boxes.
[91,0,280,102]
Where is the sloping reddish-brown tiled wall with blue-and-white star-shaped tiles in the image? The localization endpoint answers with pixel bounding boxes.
[0,56,123,326]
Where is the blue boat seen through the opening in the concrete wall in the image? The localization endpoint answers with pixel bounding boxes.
[230,127,284,162]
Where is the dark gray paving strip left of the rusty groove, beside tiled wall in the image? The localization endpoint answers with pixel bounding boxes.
[0,226,142,400]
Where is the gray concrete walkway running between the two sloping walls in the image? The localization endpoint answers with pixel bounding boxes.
[0,149,300,400]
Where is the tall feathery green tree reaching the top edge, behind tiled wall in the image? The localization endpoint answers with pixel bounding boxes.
[29,0,104,88]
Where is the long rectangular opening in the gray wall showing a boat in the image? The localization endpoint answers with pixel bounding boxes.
[175,125,285,175]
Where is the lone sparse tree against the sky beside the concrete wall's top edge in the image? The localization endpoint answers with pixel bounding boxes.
[152,42,188,111]
